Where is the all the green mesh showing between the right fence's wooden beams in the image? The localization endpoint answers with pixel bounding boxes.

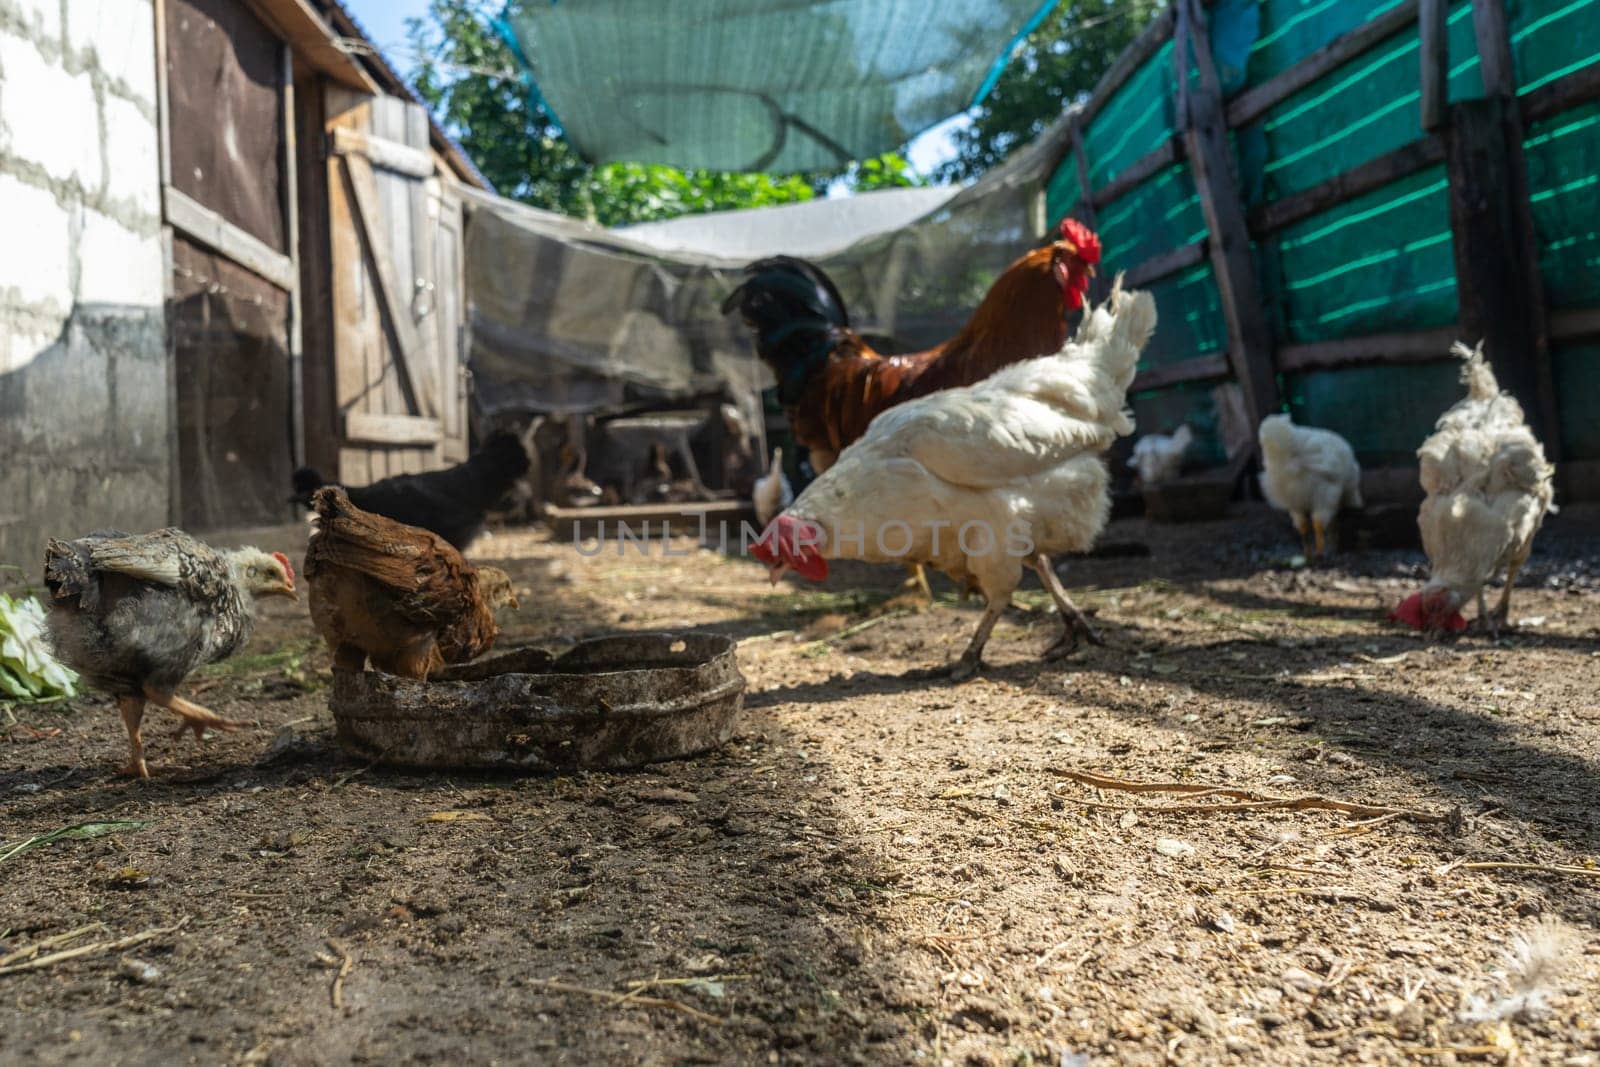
[1048,0,1600,464]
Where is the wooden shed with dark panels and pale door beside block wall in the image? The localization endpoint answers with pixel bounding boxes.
[155,0,488,530]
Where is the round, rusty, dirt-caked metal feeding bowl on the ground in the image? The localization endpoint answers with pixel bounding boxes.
[328,633,744,771]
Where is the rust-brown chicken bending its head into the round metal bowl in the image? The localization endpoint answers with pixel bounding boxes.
[306,485,517,681]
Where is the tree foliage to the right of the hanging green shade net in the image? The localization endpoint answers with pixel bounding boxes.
[936,0,1163,181]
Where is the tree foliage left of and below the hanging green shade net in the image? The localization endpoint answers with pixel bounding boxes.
[406,0,925,226]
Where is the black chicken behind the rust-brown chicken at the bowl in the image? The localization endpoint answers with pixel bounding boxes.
[290,430,530,549]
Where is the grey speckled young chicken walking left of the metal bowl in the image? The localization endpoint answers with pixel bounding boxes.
[45,530,299,777]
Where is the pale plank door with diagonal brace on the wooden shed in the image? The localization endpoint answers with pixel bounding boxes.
[326,88,466,485]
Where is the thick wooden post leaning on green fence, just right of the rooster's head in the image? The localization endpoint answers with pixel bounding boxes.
[1176,0,1282,424]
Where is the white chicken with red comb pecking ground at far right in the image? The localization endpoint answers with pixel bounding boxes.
[1390,344,1555,635]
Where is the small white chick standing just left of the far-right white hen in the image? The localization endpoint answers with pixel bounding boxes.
[1259,414,1362,555]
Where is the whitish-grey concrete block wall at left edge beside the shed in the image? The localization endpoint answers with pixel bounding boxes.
[0,0,171,575]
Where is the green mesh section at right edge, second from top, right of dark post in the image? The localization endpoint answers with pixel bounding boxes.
[1523,101,1600,307]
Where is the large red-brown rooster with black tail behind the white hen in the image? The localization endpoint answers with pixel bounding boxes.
[722,219,1101,474]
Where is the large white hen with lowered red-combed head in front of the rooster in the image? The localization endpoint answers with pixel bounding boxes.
[754,278,1155,678]
